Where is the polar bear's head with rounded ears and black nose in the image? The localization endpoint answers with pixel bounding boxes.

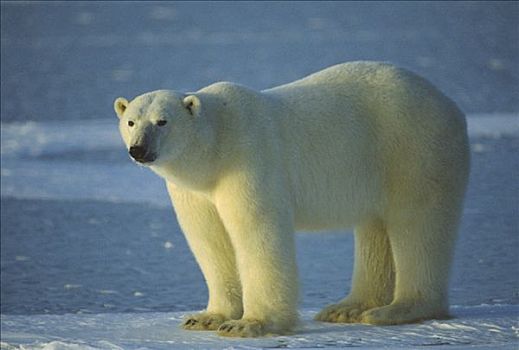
[114,90,205,166]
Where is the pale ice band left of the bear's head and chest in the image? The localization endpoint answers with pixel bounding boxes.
[1,119,169,206]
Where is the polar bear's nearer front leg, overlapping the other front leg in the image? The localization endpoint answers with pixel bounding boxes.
[216,179,298,337]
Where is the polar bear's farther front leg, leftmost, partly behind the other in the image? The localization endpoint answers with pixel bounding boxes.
[167,183,243,330]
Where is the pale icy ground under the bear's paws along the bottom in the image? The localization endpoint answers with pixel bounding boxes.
[2,305,519,350]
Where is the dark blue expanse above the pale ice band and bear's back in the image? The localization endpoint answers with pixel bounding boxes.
[1,1,519,122]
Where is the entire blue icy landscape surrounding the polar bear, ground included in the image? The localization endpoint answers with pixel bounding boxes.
[0,2,519,349]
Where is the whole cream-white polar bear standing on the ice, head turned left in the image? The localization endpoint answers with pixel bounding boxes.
[114,62,469,337]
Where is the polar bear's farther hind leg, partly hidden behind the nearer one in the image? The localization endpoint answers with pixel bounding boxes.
[315,220,395,323]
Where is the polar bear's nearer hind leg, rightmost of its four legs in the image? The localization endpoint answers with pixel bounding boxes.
[361,204,460,324]
